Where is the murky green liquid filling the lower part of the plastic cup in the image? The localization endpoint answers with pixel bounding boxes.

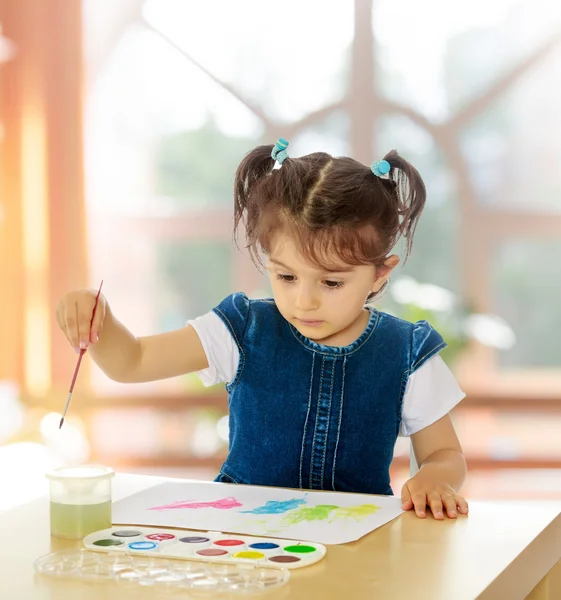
[51,500,111,540]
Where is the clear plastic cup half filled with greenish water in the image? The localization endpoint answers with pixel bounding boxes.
[47,465,115,540]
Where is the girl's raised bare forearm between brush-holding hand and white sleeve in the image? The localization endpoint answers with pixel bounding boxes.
[88,306,208,383]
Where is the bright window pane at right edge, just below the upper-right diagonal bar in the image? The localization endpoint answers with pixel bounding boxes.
[462,45,561,212]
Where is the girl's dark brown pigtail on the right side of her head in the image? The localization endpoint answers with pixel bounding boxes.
[384,150,427,262]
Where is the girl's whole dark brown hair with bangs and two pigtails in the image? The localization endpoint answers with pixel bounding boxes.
[234,146,426,270]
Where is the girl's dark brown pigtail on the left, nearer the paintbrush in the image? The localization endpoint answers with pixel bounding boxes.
[234,145,275,252]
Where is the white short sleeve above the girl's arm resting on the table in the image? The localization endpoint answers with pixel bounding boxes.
[400,355,465,436]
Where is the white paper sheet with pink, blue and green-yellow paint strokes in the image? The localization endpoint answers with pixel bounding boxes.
[113,481,403,544]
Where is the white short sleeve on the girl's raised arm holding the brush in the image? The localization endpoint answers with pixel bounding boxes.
[187,311,240,387]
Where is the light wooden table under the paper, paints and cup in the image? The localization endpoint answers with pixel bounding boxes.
[0,474,561,600]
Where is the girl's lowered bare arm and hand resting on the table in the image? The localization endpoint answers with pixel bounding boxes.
[401,415,468,519]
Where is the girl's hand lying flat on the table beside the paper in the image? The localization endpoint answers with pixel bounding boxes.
[401,465,468,520]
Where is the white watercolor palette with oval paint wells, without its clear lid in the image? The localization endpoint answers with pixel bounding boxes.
[83,527,326,569]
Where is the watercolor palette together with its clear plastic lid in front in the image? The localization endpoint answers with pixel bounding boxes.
[34,526,326,594]
